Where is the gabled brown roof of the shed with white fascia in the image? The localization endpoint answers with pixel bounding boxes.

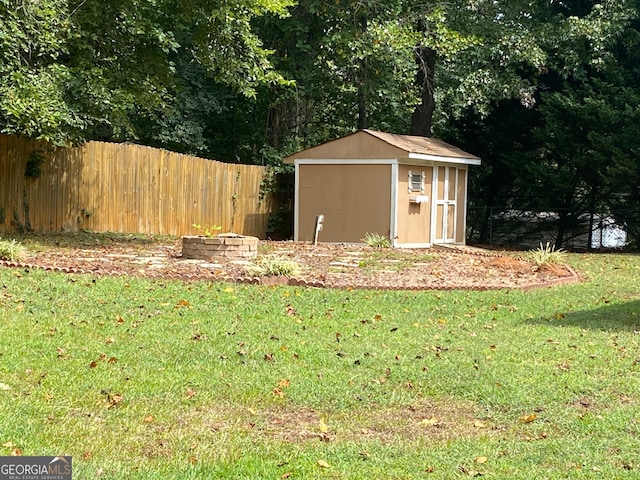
[284,130,480,165]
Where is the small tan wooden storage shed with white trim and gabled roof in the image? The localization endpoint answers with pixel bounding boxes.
[284,130,480,248]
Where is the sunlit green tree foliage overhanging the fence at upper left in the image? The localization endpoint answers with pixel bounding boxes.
[0,0,291,144]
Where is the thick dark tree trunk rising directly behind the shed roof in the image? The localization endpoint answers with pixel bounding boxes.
[410,47,436,137]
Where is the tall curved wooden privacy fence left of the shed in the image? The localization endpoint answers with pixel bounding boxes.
[0,135,274,238]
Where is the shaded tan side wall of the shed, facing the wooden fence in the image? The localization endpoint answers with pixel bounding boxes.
[297,164,391,242]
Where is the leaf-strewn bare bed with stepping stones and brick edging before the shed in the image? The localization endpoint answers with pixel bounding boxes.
[1,241,579,290]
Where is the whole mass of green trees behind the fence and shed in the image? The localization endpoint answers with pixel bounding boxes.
[0,0,640,246]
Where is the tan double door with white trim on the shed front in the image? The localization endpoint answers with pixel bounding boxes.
[432,166,458,248]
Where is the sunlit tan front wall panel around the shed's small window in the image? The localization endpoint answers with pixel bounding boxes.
[396,165,433,245]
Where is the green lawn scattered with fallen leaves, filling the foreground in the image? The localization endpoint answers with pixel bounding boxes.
[0,246,640,480]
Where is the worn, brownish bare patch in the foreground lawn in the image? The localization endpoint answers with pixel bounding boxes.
[151,398,505,446]
